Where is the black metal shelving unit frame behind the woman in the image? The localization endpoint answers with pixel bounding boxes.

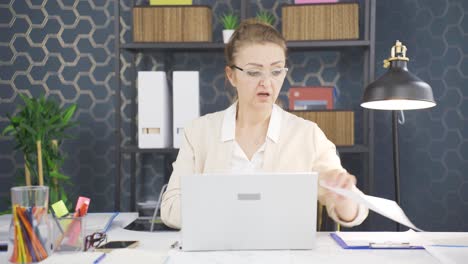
[115,0,376,228]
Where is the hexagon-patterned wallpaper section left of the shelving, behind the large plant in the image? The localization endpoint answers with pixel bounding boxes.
[0,0,116,211]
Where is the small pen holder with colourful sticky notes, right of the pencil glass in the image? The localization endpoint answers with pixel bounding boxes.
[52,216,86,252]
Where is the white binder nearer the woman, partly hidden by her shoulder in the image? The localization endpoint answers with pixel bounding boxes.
[172,71,200,148]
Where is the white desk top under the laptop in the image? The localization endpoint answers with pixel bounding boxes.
[0,213,458,264]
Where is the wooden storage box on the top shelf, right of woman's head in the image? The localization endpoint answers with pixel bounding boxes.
[282,3,359,40]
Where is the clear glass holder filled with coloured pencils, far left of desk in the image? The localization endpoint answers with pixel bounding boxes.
[8,186,51,263]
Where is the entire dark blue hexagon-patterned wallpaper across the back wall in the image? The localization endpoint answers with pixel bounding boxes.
[0,0,468,231]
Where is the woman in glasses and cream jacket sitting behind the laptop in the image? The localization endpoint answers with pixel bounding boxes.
[161,20,368,228]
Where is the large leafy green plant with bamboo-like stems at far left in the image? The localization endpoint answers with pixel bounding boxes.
[2,94,76,208]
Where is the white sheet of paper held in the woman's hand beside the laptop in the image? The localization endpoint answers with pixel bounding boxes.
[320,181,422,231]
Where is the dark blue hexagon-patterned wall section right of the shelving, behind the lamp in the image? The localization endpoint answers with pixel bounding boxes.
[375,0,468,231]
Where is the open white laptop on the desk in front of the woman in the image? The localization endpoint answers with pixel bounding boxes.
[181,173,318,251]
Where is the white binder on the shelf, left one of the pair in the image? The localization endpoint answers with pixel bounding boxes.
[138,71,172,148]
